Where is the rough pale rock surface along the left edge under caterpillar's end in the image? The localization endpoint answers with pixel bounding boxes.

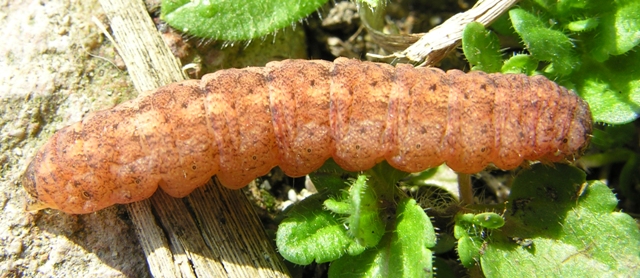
[0,0,149,277]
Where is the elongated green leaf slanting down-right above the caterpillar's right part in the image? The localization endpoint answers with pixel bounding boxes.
[509,9,580,76]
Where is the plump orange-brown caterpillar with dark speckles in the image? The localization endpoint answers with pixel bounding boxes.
[23,58,592,213]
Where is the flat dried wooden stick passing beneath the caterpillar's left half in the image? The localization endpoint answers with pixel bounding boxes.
[92,0,288,277]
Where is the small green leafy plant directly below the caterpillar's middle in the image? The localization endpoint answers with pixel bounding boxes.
[276,162,436,277]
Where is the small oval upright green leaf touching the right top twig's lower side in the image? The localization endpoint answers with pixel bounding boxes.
[462,22,502,73]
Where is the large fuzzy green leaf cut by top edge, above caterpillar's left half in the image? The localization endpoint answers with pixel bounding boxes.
[161,0,327,41]
